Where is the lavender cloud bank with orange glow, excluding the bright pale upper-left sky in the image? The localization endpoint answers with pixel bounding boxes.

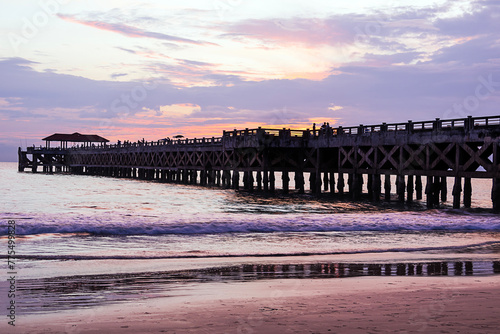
[0,1,500,159]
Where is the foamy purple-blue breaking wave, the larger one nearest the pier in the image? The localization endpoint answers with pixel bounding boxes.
[0,212,500,236]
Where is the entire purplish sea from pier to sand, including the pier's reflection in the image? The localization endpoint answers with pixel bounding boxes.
[0,163,500,316]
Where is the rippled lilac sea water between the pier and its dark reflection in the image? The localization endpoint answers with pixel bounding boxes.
[0,163,500,314]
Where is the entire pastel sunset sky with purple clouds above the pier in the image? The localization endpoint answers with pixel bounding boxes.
[0,0,500,161]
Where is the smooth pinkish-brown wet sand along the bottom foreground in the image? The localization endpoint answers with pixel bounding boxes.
[11,276,500,333]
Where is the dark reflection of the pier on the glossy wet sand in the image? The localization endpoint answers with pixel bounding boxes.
[17,261,500,314]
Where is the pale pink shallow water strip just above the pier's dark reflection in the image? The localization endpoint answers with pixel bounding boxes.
[12,245,500,279]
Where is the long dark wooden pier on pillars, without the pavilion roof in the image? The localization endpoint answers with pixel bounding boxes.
[19,116,500,210]
